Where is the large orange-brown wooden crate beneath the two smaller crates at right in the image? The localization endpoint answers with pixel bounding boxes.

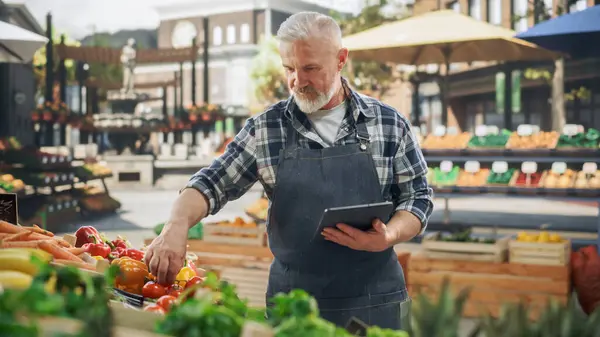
[408,254,571,318]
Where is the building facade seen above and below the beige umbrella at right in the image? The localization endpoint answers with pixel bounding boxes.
[413,0,600,132]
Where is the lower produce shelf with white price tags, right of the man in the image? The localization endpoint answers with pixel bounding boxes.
[423,144,600,252]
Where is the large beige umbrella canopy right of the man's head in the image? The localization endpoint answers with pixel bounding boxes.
[343,10,560,65]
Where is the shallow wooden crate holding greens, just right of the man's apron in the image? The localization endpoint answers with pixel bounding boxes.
[421,232,510,263]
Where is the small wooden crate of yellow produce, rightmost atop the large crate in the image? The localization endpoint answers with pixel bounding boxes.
[508,240,571,266]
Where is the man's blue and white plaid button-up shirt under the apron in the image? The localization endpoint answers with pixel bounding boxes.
[186,82,433,231]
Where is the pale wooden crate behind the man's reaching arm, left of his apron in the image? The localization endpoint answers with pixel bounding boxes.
[202,223,266,246]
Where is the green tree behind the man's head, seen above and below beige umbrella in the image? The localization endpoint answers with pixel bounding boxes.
[332,0,407,95]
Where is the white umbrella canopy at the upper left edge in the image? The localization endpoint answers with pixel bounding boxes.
[0,21,48,62]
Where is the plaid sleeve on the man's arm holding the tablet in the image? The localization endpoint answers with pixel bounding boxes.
[392,123,433,234]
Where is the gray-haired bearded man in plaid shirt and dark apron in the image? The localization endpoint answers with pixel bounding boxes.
[145,12,433,329]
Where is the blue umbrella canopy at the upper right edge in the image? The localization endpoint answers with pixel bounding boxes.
[516,5,600,58]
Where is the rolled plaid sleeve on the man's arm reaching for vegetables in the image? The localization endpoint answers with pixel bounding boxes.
[185,118,258,214]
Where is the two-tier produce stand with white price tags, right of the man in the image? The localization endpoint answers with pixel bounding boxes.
[421,125,600,248]
